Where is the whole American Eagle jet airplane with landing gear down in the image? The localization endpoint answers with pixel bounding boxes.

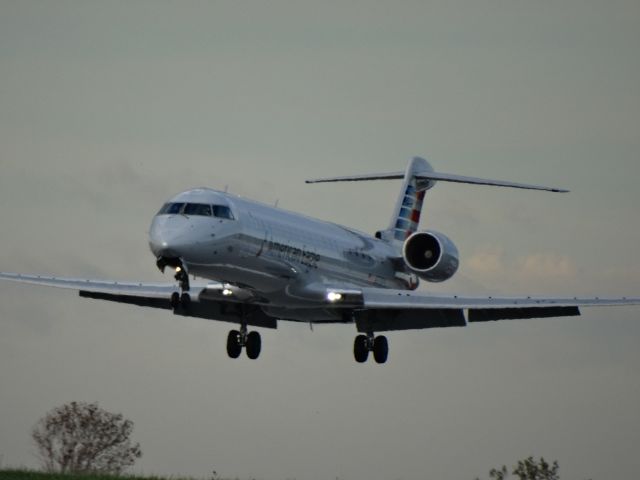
[0,157,640,363]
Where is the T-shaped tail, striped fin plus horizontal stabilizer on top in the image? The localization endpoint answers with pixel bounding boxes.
[307,157,568,243]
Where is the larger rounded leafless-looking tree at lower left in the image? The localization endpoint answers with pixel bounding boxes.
[31,402,142,474]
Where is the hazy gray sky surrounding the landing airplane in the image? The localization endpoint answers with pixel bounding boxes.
[0,0,640,480]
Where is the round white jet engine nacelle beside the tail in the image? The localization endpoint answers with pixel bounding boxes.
[402,231,459,282]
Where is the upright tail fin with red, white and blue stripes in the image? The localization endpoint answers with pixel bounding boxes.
[382,157,435,242]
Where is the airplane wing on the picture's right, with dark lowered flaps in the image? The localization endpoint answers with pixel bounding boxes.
[344,288,640,332]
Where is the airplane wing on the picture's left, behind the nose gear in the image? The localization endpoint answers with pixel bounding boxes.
[0,272,277,328]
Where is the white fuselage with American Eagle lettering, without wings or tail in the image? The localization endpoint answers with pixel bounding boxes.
[149,188,409,312]
